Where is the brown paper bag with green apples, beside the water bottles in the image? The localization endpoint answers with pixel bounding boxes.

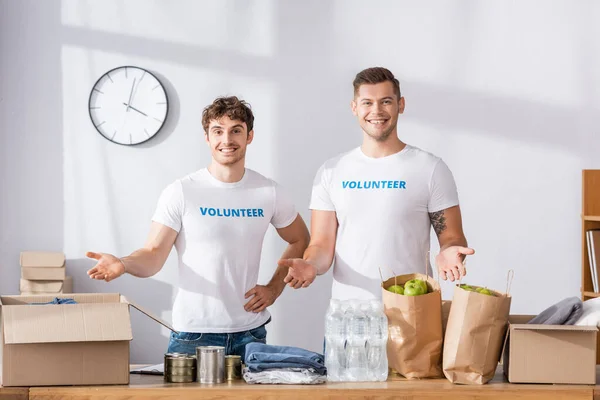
[381,274,443,379]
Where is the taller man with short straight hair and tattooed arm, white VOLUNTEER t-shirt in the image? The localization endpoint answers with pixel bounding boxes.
[280,67,474,299]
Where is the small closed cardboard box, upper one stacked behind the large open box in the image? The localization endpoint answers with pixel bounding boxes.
[21,251,66,281]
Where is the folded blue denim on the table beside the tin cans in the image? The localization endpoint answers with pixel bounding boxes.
[246,342,327,375]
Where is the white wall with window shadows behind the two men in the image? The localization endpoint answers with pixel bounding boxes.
[0,0,600,362]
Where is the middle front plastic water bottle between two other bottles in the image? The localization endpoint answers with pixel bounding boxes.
[344,301,369,382]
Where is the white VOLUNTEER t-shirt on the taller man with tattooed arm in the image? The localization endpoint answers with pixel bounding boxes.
[310,145,458,299]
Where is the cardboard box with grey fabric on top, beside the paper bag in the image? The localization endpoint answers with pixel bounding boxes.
[503,315,598,385]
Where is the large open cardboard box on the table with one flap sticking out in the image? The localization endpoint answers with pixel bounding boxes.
[0,293,172,386]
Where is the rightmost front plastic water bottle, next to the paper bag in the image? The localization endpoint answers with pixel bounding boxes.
[367,300,388,381]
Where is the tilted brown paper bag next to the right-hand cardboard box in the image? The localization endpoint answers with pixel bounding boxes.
[443,271,512,385]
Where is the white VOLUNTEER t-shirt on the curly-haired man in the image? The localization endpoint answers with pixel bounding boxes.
[152,168,298,333]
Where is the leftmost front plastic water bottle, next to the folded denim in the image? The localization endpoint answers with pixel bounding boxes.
[325,299,346,382]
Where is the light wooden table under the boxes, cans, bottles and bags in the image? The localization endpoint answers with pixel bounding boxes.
[16,369,600,400]
